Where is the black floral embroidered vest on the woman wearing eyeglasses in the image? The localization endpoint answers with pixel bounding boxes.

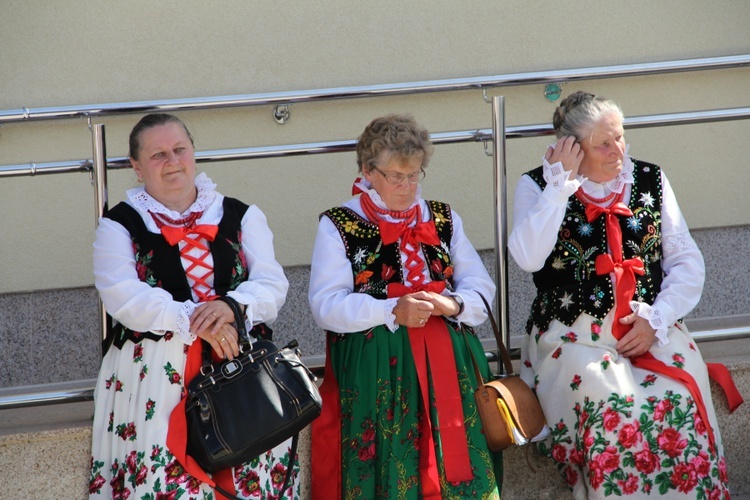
[321,201,453,299]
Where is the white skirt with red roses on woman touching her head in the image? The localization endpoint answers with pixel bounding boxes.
[521,313,729,499]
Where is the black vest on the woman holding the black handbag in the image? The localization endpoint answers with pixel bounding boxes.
[104,197,248,352]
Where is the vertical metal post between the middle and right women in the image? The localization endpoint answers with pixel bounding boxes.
[492,96,510,366]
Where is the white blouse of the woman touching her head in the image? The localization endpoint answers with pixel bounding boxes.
[508,149,705,345]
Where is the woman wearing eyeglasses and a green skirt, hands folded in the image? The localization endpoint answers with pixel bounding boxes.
[309,115,502,499]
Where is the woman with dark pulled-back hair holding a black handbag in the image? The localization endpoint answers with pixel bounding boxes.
[89,114,299,500]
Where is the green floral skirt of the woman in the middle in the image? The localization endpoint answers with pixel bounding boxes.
[329,326,502,499]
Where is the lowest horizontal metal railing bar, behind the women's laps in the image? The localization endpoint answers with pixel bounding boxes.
[0,326,750,411]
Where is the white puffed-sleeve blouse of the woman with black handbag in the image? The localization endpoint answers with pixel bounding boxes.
[94,173,289,344]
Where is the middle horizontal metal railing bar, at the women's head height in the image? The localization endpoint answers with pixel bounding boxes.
[0,107,750,178]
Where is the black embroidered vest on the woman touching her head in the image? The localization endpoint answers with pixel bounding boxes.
[526,159,662,333]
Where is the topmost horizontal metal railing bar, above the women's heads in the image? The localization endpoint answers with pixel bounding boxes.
[0,54,750,124]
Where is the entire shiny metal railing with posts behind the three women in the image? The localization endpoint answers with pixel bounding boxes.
[0,55,750,410]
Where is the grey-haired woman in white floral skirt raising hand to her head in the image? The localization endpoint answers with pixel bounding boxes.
[508,92,742,498]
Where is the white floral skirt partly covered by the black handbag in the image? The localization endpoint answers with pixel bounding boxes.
[89,333,299,500]
